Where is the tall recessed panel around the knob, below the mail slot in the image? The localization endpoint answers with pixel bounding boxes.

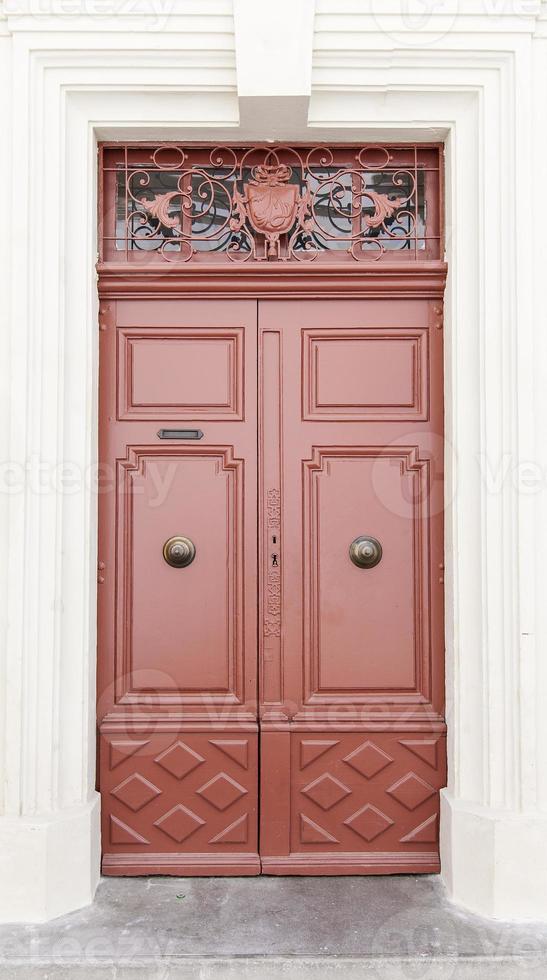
[117,446,244,703]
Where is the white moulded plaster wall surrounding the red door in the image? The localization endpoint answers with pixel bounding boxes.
[0,0,547,921]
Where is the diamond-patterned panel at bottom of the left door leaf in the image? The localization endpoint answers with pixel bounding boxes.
[100,730,258,860]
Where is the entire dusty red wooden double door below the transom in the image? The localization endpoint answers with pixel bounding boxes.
[98,298,445,875]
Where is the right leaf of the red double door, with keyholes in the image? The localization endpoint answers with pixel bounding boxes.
[259,299,445,874]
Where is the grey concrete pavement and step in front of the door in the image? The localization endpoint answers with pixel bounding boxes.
[0,875,547,980]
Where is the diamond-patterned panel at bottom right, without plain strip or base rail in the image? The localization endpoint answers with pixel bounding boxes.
[291,731,446,856]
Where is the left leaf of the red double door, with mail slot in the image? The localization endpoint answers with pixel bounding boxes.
[98,300,260,874]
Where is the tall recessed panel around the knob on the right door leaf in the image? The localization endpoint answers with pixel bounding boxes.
[303,446,427,695]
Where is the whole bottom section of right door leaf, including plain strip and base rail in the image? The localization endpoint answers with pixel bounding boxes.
[262,730,446,875]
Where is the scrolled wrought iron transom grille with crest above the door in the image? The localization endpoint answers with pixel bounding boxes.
[100,143,442,262]
